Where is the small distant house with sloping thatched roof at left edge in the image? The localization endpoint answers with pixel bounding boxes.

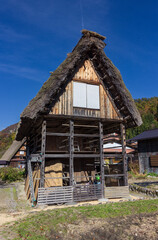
[0,138,26,168]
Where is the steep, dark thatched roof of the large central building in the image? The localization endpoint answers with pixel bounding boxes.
[17,30,142,140]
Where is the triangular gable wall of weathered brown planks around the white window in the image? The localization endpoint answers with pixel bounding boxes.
[50,60,120,119]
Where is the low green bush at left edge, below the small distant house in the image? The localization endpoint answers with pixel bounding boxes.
[0,167,25,182]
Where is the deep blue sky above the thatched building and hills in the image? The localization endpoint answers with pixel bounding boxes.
[0,0,158,130]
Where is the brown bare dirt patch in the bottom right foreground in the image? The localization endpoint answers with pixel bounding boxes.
[58,213,158,240]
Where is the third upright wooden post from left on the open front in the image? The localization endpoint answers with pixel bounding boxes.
[99,122,105,198]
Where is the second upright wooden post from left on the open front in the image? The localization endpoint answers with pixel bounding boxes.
[69,120,74,186]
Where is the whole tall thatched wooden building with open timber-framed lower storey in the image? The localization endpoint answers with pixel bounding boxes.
[16,30,142,204]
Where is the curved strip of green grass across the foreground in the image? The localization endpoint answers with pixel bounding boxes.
[3,199,158,240]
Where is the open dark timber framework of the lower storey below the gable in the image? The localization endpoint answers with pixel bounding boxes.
[27,115,128,204]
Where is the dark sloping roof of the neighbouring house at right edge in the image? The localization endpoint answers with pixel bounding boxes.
[130,128,158,141]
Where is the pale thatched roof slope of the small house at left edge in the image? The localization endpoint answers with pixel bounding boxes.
[0,138,26,162]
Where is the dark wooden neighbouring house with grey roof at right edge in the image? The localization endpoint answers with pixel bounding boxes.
[131,128,158,173]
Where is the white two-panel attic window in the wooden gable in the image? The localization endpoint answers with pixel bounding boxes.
[73,82,100,109]
